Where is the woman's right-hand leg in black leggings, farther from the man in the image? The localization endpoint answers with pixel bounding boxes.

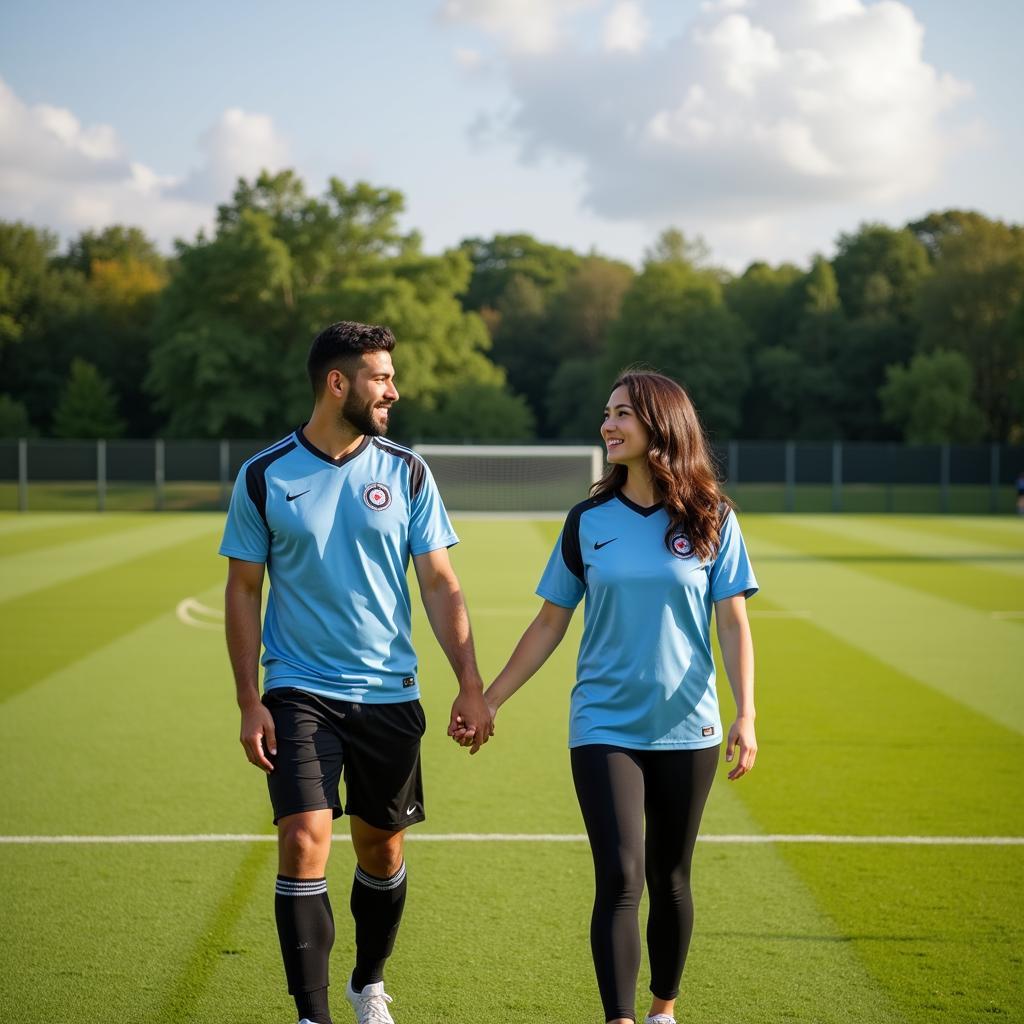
[643,746,721,1014]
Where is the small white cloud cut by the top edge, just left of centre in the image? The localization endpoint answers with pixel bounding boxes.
[440,0,597,54]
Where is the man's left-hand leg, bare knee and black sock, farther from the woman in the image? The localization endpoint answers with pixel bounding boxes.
[273,808,334,1024]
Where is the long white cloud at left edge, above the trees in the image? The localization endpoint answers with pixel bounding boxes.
[0,79,287,246]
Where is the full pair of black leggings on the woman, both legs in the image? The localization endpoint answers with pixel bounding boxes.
[570,745,720,1021]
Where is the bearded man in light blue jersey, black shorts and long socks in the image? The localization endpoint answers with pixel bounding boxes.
[220,323,492,1024]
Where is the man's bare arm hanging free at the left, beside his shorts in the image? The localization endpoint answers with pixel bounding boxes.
[224,558,278,772]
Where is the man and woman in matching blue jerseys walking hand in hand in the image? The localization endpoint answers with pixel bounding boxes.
[220,322,757,1024]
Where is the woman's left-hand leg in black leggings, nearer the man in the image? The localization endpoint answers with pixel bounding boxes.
[570,745,644,1021]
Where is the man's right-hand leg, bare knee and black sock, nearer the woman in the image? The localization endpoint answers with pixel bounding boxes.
[349,816,406,992]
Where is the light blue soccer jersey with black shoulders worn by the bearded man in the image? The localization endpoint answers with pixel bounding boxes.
[220,429,459,703]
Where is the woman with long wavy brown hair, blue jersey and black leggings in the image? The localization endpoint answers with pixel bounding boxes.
[452,373,758,1024]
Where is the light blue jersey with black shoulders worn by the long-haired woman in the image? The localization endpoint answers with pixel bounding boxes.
[537,494,758,750]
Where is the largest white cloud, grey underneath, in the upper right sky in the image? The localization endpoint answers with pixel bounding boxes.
[445,0,970,223]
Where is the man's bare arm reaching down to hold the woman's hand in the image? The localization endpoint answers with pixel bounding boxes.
[413,548,494,754]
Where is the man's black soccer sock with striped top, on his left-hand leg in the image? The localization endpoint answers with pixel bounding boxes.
[273,874,334,1024]
